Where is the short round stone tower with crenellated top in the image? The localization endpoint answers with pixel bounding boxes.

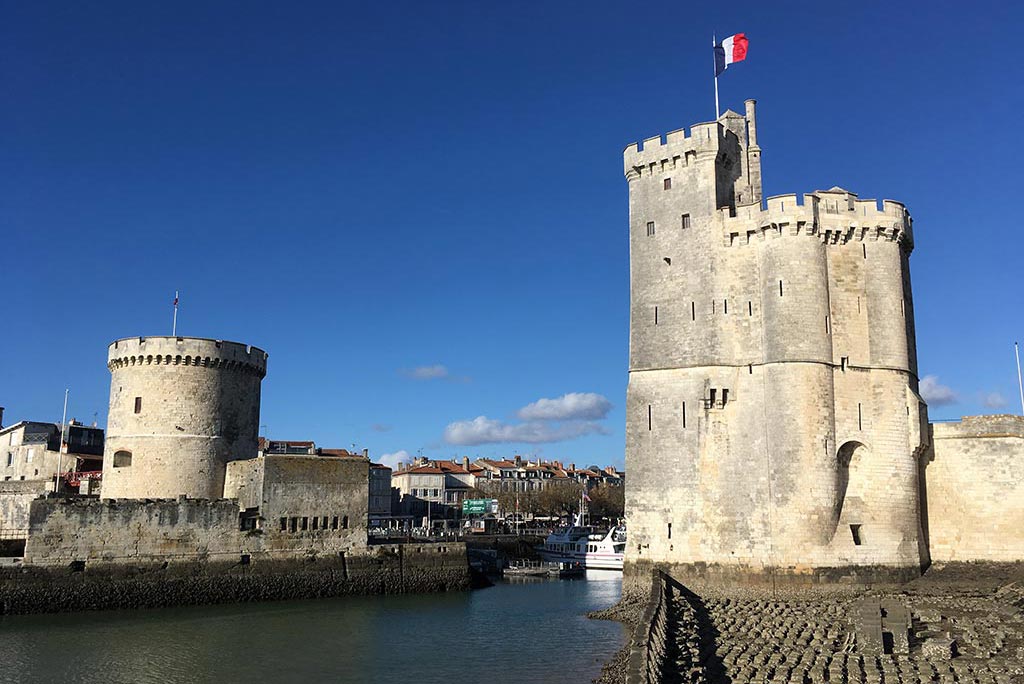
[102,337,267,499]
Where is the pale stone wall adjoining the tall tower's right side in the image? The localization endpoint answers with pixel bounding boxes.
[925,416,1024,562]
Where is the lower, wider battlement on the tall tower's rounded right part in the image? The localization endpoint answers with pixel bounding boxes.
[719,187,913,251]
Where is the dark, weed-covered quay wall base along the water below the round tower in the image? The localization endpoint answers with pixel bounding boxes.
[0,543,470,614]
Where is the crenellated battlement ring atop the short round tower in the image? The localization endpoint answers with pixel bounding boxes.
[106,336,268,378]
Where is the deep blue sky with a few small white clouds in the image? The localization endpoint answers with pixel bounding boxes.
[0,2,1024,471]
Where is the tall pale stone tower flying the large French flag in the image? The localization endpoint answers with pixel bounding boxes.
[624,100,927,581]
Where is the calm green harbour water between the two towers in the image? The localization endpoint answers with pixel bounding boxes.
[0,571,626,684]
